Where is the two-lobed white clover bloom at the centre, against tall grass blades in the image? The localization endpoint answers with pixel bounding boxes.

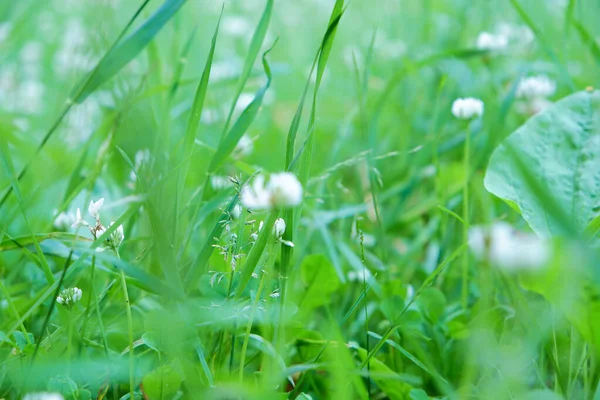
[241,172,303,210]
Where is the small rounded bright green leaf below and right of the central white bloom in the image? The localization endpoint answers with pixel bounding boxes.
[299,254,340,313]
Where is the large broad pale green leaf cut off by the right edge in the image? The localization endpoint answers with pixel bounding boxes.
[484,91,600,237]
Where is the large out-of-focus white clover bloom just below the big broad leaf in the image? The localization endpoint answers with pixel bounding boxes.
[469,222,551,271]
